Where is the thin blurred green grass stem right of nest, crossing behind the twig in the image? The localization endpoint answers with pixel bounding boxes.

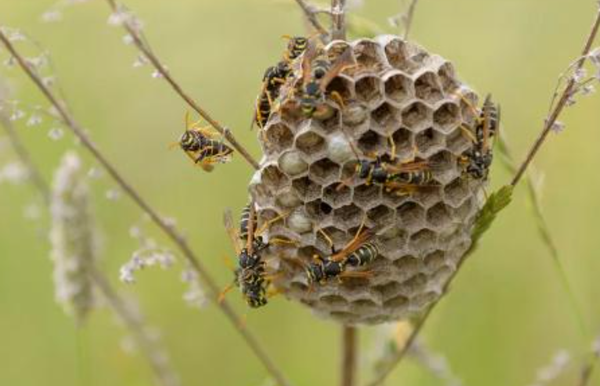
[498,134,589,340]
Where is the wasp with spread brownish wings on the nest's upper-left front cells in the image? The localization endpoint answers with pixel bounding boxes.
[300,40,356,117]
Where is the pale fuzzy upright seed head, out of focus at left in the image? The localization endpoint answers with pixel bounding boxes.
[50,152,97,323]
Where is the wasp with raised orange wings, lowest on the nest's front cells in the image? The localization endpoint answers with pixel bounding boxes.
[305,222,379,284]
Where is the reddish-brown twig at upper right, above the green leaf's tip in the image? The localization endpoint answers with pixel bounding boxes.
[511,7,600,186]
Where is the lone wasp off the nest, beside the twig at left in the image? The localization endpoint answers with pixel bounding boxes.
[174,113,233,172]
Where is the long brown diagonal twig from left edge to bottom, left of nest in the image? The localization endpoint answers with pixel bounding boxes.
[0,30,289,386]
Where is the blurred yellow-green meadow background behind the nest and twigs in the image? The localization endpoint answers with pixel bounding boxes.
[0,0,600,386]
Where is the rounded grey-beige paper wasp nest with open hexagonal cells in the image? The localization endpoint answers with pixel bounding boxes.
[250,36,483,324]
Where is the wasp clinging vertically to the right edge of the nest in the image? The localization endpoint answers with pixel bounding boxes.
[459,94,500,180]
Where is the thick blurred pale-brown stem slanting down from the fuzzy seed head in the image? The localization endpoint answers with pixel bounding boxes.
[89,268,178,386]
